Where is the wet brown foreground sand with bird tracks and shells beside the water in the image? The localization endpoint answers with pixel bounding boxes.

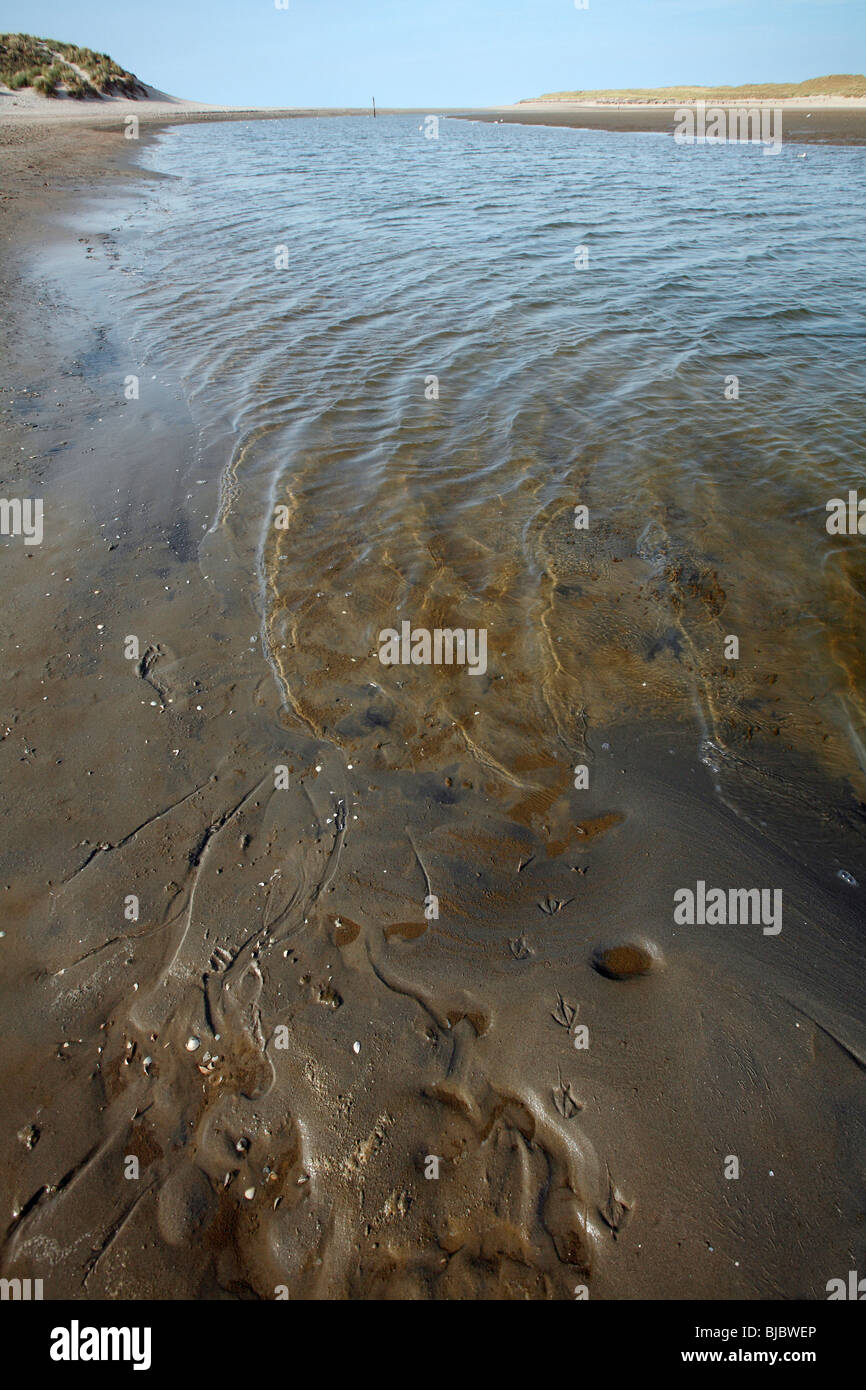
[0,113,866,1300]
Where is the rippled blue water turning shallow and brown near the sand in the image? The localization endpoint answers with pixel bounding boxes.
[116,117,866,817]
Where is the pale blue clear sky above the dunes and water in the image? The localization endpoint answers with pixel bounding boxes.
[0,0,866,110]
